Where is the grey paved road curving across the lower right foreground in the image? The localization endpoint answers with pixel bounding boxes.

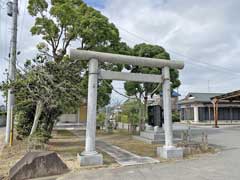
[60,127,240,180]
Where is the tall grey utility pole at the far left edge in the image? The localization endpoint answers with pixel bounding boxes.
[5,0,18,144]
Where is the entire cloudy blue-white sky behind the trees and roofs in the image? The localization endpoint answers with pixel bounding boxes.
[0,0,240,104]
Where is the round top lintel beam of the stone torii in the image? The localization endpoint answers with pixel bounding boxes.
[68,49,184,69]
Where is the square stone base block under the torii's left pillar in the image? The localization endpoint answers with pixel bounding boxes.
[77,152,103,166]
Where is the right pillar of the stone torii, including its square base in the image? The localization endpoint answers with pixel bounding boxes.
[157,66,183,159]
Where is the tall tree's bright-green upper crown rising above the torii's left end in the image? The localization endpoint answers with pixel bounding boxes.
[28,0,120,62]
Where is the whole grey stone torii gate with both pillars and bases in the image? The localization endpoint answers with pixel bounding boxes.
[69,49,184,166]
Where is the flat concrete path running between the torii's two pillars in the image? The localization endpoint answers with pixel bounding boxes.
[97,141,159,166]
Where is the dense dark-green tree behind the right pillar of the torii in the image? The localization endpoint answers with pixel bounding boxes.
[124,43,181,126]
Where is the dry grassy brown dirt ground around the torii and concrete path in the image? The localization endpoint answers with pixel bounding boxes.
[0,130,217,177]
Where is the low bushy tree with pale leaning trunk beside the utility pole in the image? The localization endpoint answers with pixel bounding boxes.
[2,56,83,139]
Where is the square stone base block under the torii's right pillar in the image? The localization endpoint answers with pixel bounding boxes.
[157,146,183,159]
